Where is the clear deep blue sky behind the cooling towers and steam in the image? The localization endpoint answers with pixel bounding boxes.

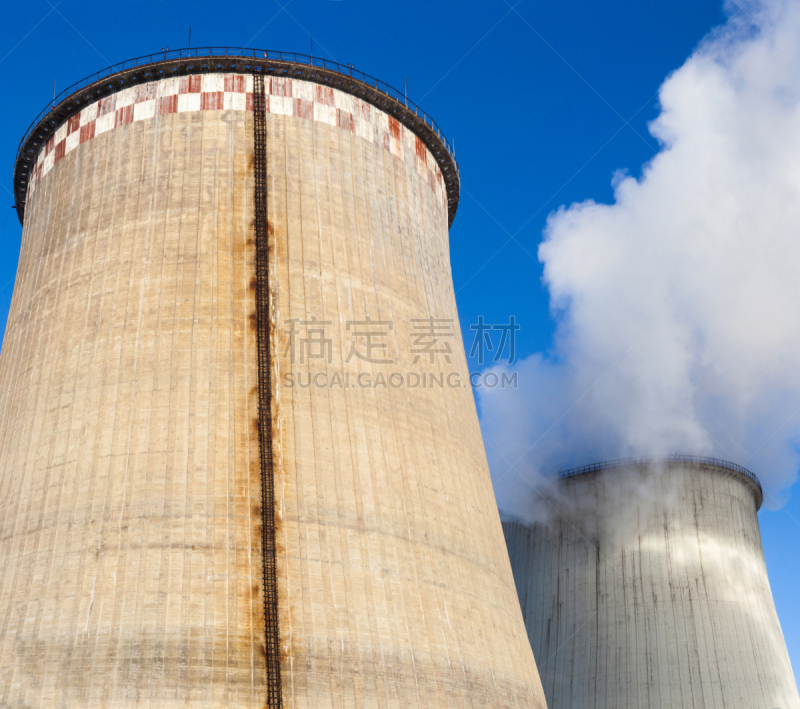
[0,0,800,670]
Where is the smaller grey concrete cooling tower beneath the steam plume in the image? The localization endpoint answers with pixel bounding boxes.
[503,456,800,709]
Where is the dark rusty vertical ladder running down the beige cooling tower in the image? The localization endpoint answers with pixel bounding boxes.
[253,70,283,709]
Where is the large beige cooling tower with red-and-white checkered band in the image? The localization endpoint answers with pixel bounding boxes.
[0,49,544,709]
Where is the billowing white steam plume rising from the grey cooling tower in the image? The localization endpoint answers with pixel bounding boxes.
[480,0,800,516]
